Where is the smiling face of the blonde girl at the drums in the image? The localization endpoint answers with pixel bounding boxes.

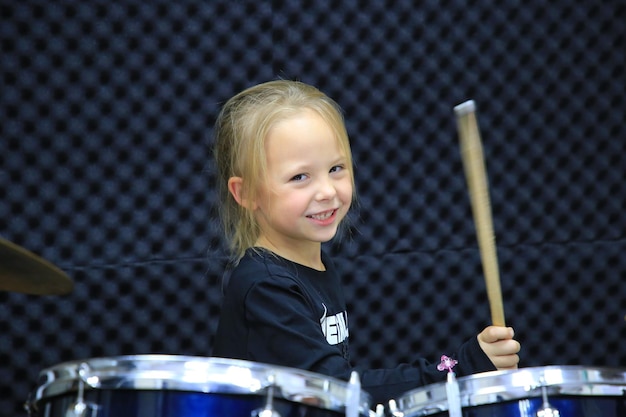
[256,110,353,250]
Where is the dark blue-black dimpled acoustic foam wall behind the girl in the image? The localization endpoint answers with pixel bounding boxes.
[0,0,626,416]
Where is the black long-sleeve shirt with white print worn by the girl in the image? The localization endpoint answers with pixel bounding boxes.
[213,248,495,404]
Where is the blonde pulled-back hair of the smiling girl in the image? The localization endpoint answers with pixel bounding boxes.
[213,80,355,260]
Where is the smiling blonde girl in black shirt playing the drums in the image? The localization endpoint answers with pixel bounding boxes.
[213,80,520,403]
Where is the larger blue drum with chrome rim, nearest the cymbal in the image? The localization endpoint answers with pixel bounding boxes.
[28,355,371,417]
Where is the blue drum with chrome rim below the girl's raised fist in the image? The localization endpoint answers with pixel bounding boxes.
[387,366,626,417]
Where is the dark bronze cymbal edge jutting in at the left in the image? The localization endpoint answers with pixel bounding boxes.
[0,238,74,295]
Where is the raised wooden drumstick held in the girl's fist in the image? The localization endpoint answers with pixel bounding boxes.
[454,100,505,326]
